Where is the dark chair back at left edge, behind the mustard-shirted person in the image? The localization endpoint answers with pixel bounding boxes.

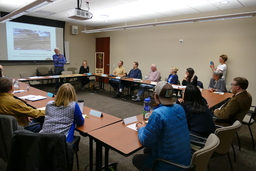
[0,114,23,163]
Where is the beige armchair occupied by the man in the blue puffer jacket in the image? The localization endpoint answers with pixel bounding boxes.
[153,134,220,171]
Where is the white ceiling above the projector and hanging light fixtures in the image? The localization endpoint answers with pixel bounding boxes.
[0,0,256,27]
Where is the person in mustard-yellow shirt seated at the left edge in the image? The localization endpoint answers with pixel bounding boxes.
[0,77,45,132]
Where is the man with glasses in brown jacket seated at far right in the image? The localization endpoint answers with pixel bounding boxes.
[214,77,252,126]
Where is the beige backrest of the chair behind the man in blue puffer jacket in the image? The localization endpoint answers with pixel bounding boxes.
[190,134,220,171]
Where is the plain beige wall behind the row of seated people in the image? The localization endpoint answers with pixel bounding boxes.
[96,17,256,103]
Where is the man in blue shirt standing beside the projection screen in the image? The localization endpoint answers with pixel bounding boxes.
[52,48,67,92]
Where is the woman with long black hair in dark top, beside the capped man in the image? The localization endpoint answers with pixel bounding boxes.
[177,85,215,138]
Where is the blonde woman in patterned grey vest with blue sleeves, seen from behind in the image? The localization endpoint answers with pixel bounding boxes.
[40,83,84,142]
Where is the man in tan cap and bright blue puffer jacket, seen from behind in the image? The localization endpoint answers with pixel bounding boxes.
[132,81,191,170]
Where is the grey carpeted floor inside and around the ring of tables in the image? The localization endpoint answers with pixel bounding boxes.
[0,83,256,171]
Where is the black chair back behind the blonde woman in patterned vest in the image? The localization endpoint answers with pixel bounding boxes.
[7,130,73,171]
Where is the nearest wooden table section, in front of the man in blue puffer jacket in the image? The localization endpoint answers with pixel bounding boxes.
[88,114,143,171]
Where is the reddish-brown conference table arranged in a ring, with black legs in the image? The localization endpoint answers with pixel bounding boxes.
[15,74,232,171]
